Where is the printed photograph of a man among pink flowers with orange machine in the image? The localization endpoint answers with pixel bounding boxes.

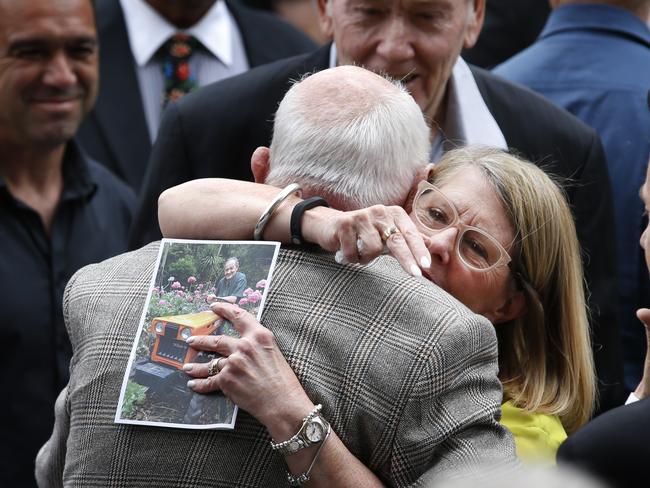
[115,239,280,429]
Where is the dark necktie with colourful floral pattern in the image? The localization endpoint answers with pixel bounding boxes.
[160,34,200,106]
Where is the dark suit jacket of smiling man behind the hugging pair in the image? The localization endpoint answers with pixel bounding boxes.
[131,45,625,409]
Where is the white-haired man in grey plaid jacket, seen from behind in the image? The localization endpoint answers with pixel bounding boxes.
[37,67,514,487]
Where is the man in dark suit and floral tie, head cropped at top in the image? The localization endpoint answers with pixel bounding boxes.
[78,0,315,191]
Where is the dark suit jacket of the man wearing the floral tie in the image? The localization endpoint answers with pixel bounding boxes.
[77,0,316,192]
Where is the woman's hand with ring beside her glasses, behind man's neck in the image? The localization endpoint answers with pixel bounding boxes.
[303,205,431,276]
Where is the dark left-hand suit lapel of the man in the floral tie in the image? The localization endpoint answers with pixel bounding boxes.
[92,1,151,186]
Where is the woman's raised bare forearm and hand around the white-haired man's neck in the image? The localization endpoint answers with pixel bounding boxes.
[158,178,430,276]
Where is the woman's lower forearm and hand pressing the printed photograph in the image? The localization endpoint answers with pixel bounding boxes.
[184,303,383,487]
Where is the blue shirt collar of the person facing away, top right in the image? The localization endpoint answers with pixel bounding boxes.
[540,4,650,47]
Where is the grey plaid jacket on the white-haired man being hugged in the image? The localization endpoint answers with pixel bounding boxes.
[36,243,515,488]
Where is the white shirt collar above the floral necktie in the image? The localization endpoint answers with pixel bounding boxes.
[120,0,235,67]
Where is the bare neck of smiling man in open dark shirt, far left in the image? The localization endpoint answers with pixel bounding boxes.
[0,144,66,234]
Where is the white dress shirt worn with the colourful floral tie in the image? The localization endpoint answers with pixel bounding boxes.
[120,0,249,143]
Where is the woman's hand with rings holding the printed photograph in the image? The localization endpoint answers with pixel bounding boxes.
[183,302,314,432]
